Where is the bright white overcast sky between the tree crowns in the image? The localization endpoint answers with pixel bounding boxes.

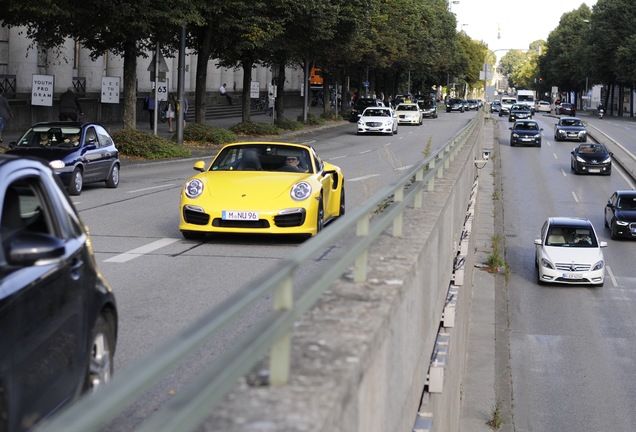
[449,0,596,58]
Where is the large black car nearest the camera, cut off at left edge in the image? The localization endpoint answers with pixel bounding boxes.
[0,155,117,432]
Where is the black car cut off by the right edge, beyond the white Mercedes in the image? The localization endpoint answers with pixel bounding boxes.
[604,189,636,240]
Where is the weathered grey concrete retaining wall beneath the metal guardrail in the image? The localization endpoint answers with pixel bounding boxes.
[200,116,483,432]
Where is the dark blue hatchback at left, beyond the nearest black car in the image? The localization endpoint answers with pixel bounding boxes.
[7,122,120,195]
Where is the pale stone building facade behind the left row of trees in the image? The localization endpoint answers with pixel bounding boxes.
[0,27,303,130]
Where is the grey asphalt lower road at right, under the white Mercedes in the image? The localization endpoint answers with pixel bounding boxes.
[499,109,636,432]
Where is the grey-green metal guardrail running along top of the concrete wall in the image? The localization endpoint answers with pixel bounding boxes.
[38,112,483,432]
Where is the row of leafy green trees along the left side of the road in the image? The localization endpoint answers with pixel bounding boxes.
[0,0,490,127]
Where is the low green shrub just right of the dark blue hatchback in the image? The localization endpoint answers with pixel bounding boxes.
[111,129,192,159]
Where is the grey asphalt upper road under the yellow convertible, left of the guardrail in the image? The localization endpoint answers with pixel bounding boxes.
[66,107,482,431]
